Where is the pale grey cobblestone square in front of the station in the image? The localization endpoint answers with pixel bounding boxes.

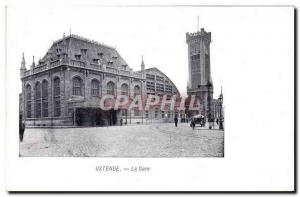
[20,123,224,157]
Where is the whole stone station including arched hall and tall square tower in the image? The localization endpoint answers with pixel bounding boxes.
[19,29,223,126]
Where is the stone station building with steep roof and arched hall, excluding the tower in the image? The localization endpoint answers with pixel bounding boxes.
[19,35,179,126]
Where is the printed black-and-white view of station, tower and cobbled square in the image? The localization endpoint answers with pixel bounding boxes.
[19,16,224,157]
